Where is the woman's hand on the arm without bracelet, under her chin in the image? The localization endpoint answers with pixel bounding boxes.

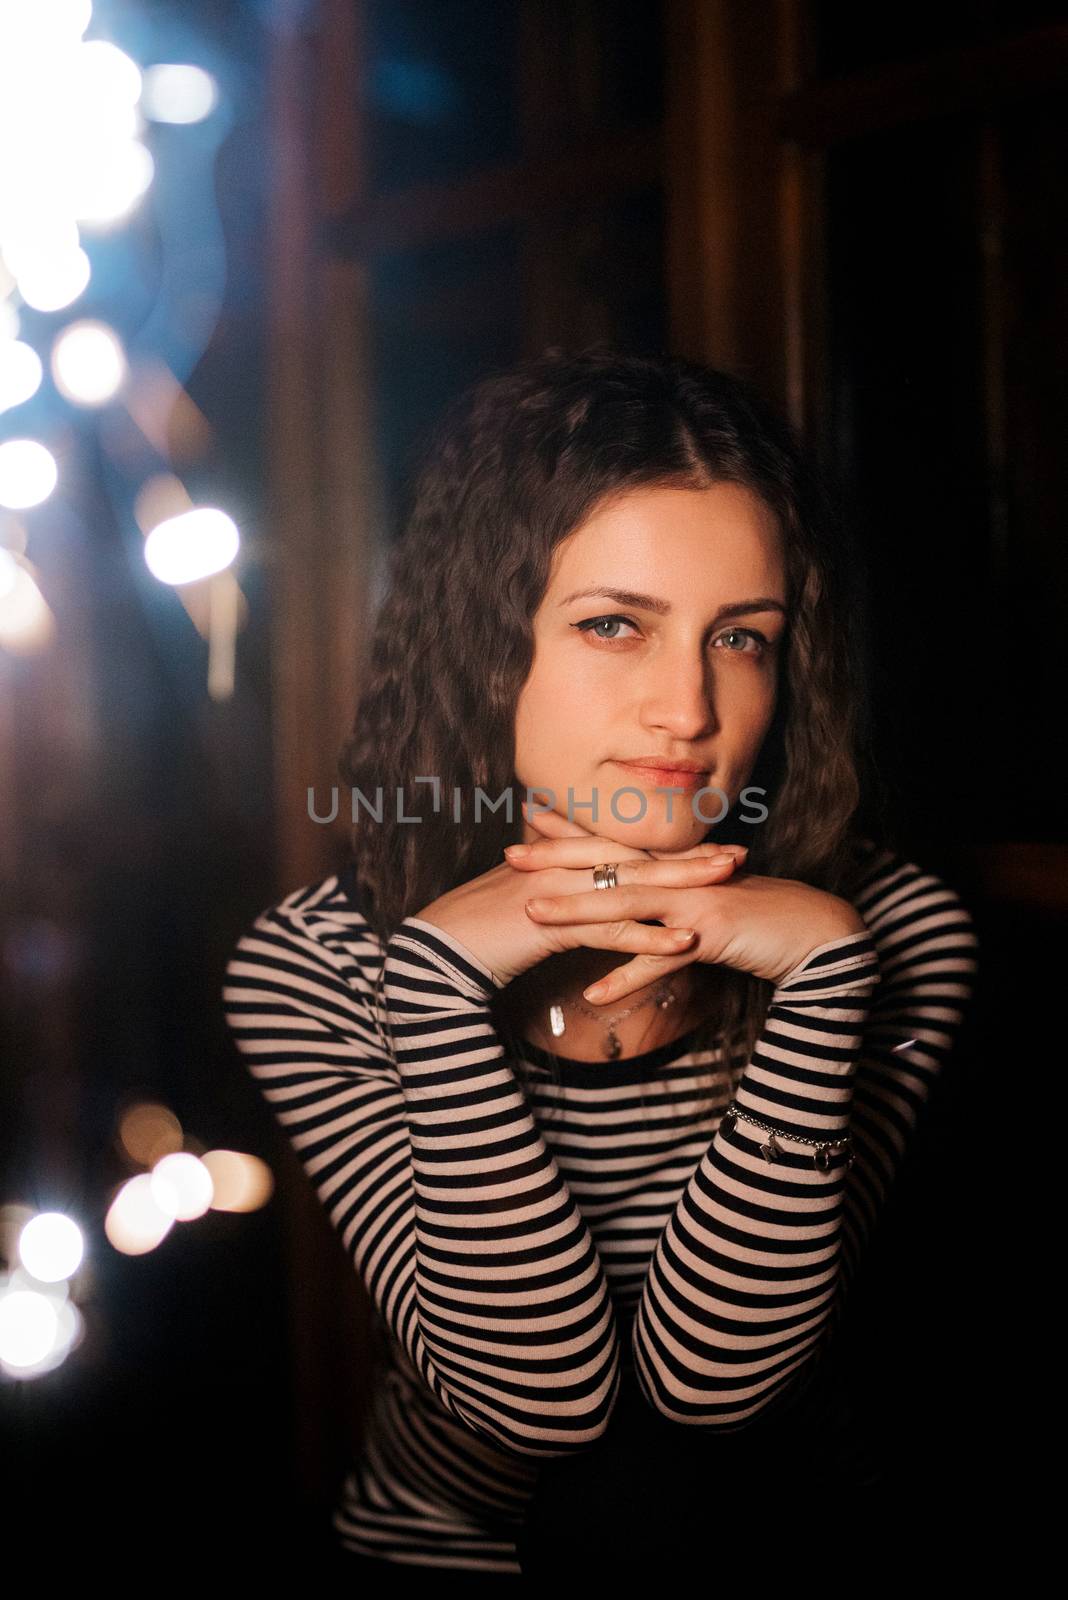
[416,830,743,984]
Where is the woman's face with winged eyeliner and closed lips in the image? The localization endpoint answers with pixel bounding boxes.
[515,483,787,851]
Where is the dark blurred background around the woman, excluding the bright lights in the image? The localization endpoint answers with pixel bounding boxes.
[0,0,1068,1581]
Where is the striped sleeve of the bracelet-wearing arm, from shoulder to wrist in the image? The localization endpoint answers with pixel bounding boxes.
[632,856,975,1430]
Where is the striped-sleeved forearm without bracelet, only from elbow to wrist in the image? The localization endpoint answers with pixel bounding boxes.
[384,917,619,1450]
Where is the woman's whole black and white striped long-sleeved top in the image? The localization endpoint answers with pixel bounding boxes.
[222,842,977,1573]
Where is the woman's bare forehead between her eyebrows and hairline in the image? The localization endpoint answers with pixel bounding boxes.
[550,483,783,603]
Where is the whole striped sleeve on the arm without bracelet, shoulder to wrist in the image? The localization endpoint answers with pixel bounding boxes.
[224,902,620,1456]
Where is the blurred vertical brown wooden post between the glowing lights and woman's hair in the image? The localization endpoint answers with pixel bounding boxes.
[262,0,381,1512]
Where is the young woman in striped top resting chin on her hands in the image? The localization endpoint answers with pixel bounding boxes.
[224,346,975,1578]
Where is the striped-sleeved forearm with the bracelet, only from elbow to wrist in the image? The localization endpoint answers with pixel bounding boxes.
[632,931,879,1429]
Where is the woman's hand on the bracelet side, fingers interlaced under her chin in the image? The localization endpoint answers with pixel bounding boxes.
[505,811,867,1005]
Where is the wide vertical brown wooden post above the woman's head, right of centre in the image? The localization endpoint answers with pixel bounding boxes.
[664,0,823,426]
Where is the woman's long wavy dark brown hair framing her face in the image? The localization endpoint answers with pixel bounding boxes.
[339,341,883,1099]
